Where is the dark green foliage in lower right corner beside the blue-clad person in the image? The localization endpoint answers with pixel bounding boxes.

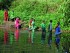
[61,32,70,49]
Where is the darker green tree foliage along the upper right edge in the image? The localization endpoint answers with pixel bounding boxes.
[64,0,70,26]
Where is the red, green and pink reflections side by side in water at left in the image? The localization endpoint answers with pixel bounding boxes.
[4,29,19,44]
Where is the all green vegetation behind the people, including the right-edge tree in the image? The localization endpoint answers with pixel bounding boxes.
[0,0,70,27]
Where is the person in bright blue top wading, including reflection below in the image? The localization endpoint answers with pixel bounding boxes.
[55,23,61,49]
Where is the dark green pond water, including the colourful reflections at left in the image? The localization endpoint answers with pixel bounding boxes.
[0,29,67,53]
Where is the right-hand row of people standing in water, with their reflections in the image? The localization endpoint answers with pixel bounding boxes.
[29,18,61,49]
